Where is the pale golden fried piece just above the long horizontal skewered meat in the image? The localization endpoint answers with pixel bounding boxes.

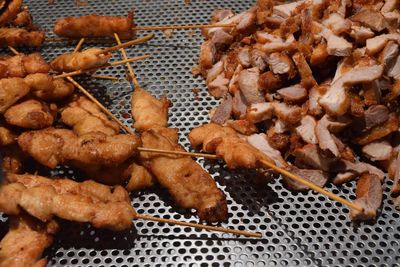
[61,96,120,136]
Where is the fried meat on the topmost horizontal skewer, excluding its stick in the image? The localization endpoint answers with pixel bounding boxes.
[54,11,135,39]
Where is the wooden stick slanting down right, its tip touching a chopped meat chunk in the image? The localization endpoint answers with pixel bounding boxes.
[260,160,364,212]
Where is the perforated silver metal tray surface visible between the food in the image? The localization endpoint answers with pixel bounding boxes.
[1,0,400,266]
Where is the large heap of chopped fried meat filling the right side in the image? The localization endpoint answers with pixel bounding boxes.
[195,0,400,222]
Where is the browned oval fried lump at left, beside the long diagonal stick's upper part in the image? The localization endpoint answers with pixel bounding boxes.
[24,73,75,101]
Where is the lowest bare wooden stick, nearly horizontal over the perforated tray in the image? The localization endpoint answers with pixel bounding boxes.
[136,214,262,238]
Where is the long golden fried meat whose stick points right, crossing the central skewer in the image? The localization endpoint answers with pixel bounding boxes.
[18,128,141,169]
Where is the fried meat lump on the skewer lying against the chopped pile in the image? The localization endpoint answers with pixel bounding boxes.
[189,123,273,168]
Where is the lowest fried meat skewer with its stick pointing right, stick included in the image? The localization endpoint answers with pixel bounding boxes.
[0,174,261,237]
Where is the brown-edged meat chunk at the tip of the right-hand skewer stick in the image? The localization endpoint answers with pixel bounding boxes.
[350,173,383,221]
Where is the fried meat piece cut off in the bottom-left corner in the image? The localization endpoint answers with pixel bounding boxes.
[0,214,59,267]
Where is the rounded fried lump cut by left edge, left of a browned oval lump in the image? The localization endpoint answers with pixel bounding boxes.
[0,78,30,114]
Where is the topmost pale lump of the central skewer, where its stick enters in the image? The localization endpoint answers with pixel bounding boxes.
[131,88,170,131]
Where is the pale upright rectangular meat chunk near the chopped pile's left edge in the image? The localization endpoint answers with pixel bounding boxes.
[239,68,265,104]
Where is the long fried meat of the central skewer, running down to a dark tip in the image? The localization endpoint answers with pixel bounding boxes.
[132,88,228,222]
